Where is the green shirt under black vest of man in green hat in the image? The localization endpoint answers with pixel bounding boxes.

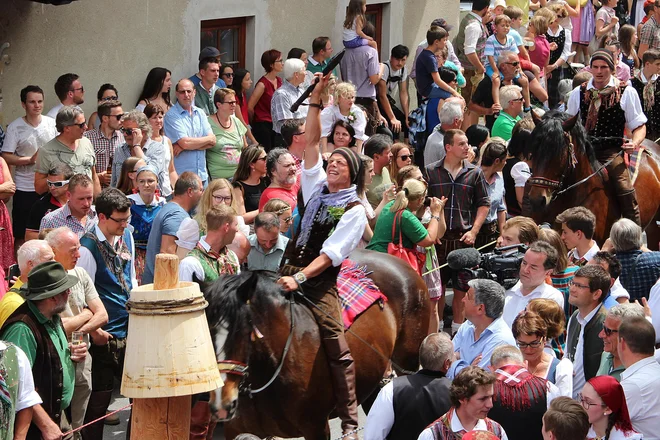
[2,301,76,408]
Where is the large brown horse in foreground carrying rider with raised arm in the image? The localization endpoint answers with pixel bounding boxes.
[204,250,431,440]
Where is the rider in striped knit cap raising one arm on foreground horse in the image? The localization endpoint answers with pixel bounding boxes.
[278,75,367,440]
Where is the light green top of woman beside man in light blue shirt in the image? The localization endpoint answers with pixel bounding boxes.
[206,116,247,179]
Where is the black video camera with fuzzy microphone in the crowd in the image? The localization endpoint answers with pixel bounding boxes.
[455,244,527,289]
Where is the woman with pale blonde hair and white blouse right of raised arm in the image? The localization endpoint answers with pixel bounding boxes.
[321,82,369,153]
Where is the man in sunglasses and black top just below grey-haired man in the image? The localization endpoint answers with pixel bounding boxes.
[25,163,73,241]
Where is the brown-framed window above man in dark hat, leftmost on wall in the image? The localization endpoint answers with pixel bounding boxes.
[200,17,247,68]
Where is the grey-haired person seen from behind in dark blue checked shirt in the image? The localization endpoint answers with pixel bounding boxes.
[602,218,660,302]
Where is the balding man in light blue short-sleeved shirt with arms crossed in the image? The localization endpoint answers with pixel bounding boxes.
[163,79,215,187]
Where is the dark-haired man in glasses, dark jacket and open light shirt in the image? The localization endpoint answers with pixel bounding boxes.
[566,265,610,399]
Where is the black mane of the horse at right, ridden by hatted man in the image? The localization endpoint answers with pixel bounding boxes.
[531,110,600,172]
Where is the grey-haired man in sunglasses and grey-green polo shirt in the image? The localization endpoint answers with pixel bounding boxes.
[34,106,101,196]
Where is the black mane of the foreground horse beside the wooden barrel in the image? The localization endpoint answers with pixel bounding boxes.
[202,270,284,360]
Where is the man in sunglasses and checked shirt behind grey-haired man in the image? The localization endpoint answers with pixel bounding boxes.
[84,100,124,188]
